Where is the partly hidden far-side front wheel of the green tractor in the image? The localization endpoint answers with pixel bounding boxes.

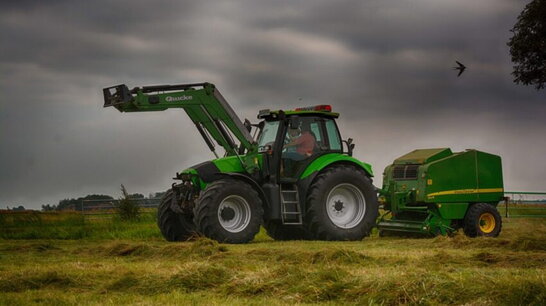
[157,189,196,241]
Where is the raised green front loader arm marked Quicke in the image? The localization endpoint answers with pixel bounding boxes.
[103,83,258,172]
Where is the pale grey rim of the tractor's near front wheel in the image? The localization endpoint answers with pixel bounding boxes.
[218,195,250,233]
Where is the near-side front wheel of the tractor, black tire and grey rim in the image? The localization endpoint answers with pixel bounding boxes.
[193,179,264,243]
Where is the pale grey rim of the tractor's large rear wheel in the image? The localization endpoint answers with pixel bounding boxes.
[326,184,366,229]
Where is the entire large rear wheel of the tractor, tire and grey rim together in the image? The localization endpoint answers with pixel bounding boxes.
[304,165,379,240]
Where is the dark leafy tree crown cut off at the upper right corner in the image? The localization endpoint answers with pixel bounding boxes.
[508,0,546,90]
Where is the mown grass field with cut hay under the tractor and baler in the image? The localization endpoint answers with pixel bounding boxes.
[0,214,546,305]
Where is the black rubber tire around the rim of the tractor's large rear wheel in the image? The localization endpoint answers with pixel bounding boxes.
[304,165,379,240]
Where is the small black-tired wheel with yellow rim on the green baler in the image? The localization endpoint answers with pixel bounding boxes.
[463,203,502,237]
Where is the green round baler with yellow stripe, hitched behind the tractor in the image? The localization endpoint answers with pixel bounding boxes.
[378,148,504,237]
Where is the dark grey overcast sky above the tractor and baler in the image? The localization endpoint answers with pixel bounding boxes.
[0,0,546,208]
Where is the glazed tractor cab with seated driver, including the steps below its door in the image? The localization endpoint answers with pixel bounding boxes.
[252,105,362,227]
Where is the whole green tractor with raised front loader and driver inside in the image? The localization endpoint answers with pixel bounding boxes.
[103,83,378,243]
